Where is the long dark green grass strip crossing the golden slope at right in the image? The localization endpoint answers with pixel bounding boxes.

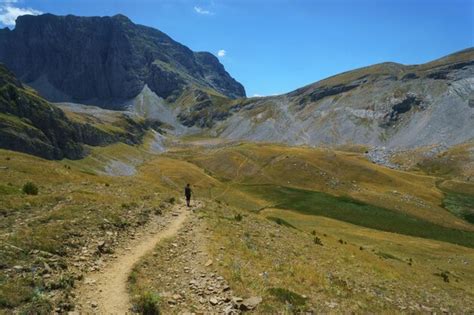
[244,186,474,248]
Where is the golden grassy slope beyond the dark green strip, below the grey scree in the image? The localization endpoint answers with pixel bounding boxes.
[181,144,473,230]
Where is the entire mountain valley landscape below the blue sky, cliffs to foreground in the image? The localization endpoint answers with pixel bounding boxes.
[0,11,474,315]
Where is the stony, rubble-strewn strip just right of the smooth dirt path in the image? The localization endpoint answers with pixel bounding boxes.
[130,204,262,314]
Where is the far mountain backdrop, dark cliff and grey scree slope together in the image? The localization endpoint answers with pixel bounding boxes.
[0,14,468,148]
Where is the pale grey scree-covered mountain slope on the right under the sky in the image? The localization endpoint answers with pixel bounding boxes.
[211,48,474,147]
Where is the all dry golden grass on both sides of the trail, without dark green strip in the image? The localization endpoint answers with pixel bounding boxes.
[0,138,474,312]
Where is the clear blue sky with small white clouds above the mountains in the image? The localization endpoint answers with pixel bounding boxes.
[0,0,474,96]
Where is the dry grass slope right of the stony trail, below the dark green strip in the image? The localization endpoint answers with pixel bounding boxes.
[206,207,474,312]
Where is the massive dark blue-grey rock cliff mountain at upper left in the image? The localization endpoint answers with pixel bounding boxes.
[0,14,245,108]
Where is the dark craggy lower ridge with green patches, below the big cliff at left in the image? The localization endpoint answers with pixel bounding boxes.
[0,65,156,159]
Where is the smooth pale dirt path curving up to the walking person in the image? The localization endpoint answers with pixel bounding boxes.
[77,203,201,314]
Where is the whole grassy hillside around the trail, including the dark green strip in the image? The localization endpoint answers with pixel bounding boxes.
[0,138,474,313]
